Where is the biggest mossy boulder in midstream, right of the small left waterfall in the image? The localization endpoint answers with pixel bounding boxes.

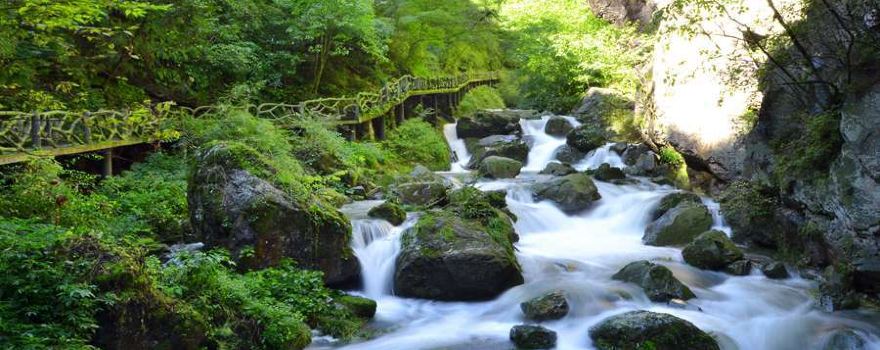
[394,211,523,301]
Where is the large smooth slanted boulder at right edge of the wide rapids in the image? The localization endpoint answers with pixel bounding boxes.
[642,202,712,246]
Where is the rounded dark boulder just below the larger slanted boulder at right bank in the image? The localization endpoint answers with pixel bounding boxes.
[681,230,743,270]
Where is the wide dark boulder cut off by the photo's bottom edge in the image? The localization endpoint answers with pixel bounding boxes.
[590,311,720,350]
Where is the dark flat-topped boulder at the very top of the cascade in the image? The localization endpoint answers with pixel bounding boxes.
[455,110,537,138]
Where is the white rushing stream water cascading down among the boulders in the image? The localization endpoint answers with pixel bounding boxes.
[324,118,880,350]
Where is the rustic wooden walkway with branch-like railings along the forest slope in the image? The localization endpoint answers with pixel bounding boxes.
[0,73,498,165]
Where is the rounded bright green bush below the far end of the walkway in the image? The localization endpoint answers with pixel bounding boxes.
[382,119,451,170]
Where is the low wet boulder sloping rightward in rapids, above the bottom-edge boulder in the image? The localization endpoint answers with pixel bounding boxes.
[611,260,696,302]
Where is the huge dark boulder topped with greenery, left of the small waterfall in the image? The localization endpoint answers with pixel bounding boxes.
[187,143,360,284]
